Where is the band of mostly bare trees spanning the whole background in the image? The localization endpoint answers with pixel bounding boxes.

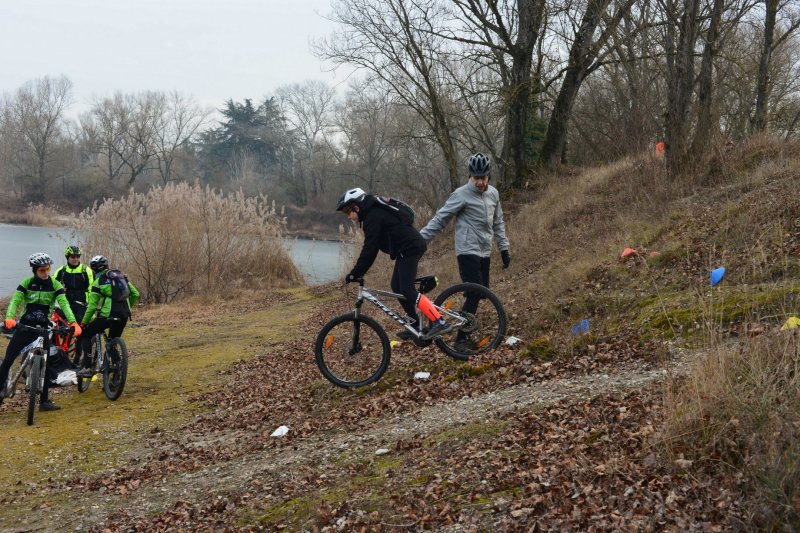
[0,0,800,209]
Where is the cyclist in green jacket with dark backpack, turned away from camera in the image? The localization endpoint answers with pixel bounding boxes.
[78,255,139,377]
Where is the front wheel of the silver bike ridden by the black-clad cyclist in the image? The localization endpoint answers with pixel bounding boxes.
[314,314,392,389]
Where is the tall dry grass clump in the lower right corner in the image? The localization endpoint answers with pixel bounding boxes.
[666,330,800,530]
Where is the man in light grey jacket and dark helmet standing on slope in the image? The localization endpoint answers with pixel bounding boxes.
[420,153,511,348]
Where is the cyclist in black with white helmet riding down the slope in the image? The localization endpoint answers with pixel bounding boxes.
[336,187,449,340]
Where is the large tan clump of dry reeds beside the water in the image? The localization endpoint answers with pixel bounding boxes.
[73,183,302,302]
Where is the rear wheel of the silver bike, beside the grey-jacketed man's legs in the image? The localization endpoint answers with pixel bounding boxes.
[433,283,507,361]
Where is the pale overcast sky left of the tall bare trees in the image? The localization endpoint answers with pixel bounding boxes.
[0,0,344,116]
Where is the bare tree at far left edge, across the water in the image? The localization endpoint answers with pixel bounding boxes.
[2,76,72,202]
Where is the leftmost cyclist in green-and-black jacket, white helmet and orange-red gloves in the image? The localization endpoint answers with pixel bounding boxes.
[0,253,81,411]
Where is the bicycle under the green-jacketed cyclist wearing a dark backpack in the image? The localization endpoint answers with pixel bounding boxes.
[77,317,128,401]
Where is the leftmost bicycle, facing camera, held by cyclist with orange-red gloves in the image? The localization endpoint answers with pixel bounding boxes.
[0,322,72,426]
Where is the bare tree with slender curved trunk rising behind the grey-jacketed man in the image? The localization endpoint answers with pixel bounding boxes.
[315,0,460,188]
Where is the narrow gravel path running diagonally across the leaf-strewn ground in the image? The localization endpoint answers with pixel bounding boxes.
[3,354,690,532]
